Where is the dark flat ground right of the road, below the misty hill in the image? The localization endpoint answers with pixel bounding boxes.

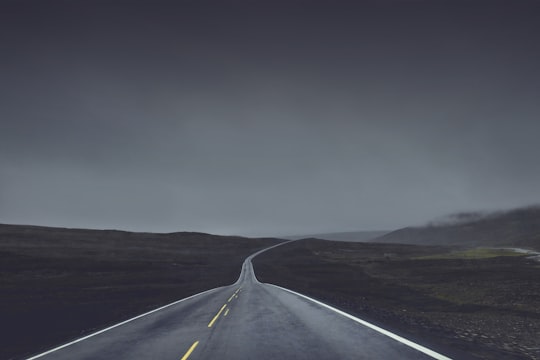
[253,239,540,359]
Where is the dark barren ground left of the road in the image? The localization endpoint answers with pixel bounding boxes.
[0,225,279,359]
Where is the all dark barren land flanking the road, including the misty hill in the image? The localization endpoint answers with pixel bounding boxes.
[0,207,540,359]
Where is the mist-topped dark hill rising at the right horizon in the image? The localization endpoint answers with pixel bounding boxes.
[374,206,540,250]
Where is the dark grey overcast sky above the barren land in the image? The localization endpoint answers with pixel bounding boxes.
[0,0,540,235]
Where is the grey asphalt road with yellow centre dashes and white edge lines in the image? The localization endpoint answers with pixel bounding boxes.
[28,244,449,360]
